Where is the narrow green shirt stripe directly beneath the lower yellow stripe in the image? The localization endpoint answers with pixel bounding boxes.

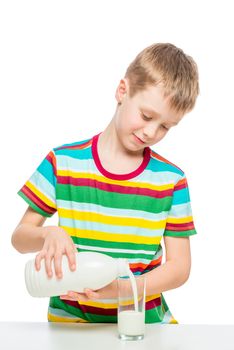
[72,236,159,251]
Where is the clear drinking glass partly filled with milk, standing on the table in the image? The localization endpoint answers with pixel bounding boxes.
[118,270,146,340]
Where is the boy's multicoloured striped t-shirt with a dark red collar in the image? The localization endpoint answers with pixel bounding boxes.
[18,134,196,323]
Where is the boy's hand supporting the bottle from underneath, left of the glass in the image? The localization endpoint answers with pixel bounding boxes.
[60,280,118,302]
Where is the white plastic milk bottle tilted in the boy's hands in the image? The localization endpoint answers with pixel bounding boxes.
[25,252,131,297]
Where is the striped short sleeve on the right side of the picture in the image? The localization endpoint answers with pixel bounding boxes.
[164,175,197,237]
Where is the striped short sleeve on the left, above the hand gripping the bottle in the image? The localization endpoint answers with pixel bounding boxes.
[18,151,57,217]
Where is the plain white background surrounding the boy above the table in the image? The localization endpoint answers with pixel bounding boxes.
[0,0,234,324]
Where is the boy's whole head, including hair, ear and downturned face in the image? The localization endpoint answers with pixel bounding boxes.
[114,44,199,151]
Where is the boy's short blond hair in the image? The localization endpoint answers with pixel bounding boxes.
[125,43,199,113]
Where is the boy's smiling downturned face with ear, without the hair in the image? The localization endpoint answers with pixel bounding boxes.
[115,79,183,153]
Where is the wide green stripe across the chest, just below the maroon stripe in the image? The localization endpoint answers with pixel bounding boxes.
[56,184,172,214]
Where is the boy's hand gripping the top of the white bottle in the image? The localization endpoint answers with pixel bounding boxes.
[35,226,77,278]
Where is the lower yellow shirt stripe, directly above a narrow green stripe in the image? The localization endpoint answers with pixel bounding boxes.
[61,226,162,244]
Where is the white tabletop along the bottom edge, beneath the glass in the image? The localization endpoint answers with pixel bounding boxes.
[0,322,234,350]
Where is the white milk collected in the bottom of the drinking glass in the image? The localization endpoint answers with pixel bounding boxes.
[118,310,145,335]
